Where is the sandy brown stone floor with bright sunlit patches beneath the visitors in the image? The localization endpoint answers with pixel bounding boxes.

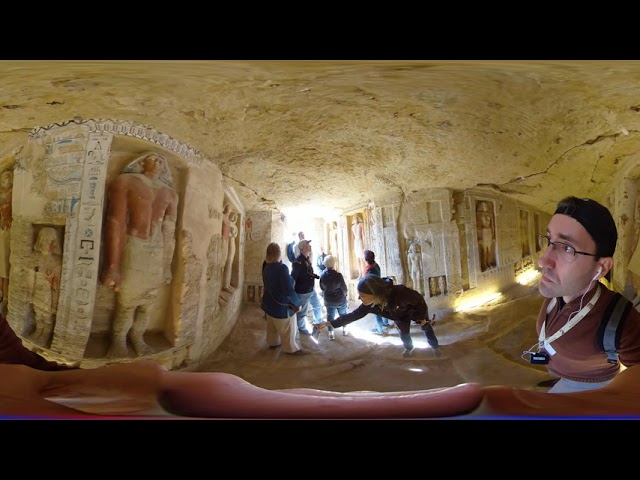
[198,285,550,392]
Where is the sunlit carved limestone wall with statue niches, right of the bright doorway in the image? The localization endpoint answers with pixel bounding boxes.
[336,189,551,312]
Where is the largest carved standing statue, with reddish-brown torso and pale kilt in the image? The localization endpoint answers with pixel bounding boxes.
[102,153,178,357]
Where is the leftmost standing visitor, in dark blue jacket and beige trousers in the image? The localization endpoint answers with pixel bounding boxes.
[260,242,308,355]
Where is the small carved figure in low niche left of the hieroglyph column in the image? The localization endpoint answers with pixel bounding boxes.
[29,227,62,346]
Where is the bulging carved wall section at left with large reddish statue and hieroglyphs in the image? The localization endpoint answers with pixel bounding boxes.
[7,120,232,368]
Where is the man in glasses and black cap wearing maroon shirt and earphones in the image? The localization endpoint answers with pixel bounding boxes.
[523,196,640,393]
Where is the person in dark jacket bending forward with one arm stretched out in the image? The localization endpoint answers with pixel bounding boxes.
[318,275,440,357]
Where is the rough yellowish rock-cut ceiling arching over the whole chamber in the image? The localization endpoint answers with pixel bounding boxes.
[0,60,640,217]
